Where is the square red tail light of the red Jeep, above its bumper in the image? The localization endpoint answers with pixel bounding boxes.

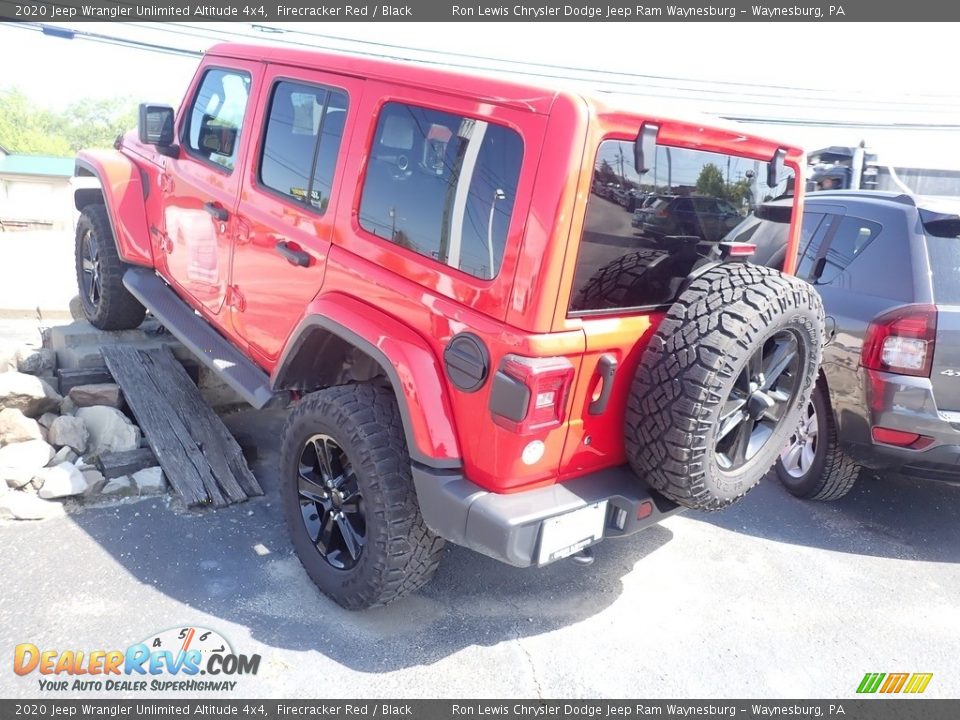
[490,355,573,435]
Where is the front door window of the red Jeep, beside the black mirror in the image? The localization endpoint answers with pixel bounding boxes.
[187,69,250,172]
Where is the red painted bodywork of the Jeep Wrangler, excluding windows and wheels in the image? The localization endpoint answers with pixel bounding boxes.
[90,44,803,492]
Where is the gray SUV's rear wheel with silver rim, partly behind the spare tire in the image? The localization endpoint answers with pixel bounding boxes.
[777,382,860,500]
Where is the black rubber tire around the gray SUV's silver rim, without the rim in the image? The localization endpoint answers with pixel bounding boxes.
[777,381,861,500]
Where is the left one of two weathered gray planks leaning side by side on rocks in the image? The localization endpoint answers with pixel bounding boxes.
[101,345,227,507]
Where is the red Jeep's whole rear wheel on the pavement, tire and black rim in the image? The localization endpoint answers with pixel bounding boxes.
[280,383,444,610]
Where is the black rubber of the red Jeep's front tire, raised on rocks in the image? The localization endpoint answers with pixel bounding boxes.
[74,204,147,330]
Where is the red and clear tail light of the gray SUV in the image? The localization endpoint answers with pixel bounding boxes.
[860,305,937,377]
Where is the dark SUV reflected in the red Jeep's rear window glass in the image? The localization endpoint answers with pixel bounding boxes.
[641,195,743,242]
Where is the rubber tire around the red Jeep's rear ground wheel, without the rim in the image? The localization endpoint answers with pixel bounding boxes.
[280,383,444,610]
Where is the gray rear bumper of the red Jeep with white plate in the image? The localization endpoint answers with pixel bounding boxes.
[413,463,683,567]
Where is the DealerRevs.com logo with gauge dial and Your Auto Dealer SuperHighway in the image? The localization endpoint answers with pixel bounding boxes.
[13,627,260,692]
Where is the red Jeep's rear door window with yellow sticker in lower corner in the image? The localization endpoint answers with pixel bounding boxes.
[260,81,347,213]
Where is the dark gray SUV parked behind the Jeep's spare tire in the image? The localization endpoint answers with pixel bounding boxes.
[727,191,960,500]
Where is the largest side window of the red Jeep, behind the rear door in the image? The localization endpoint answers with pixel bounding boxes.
[360,103,523,278]
